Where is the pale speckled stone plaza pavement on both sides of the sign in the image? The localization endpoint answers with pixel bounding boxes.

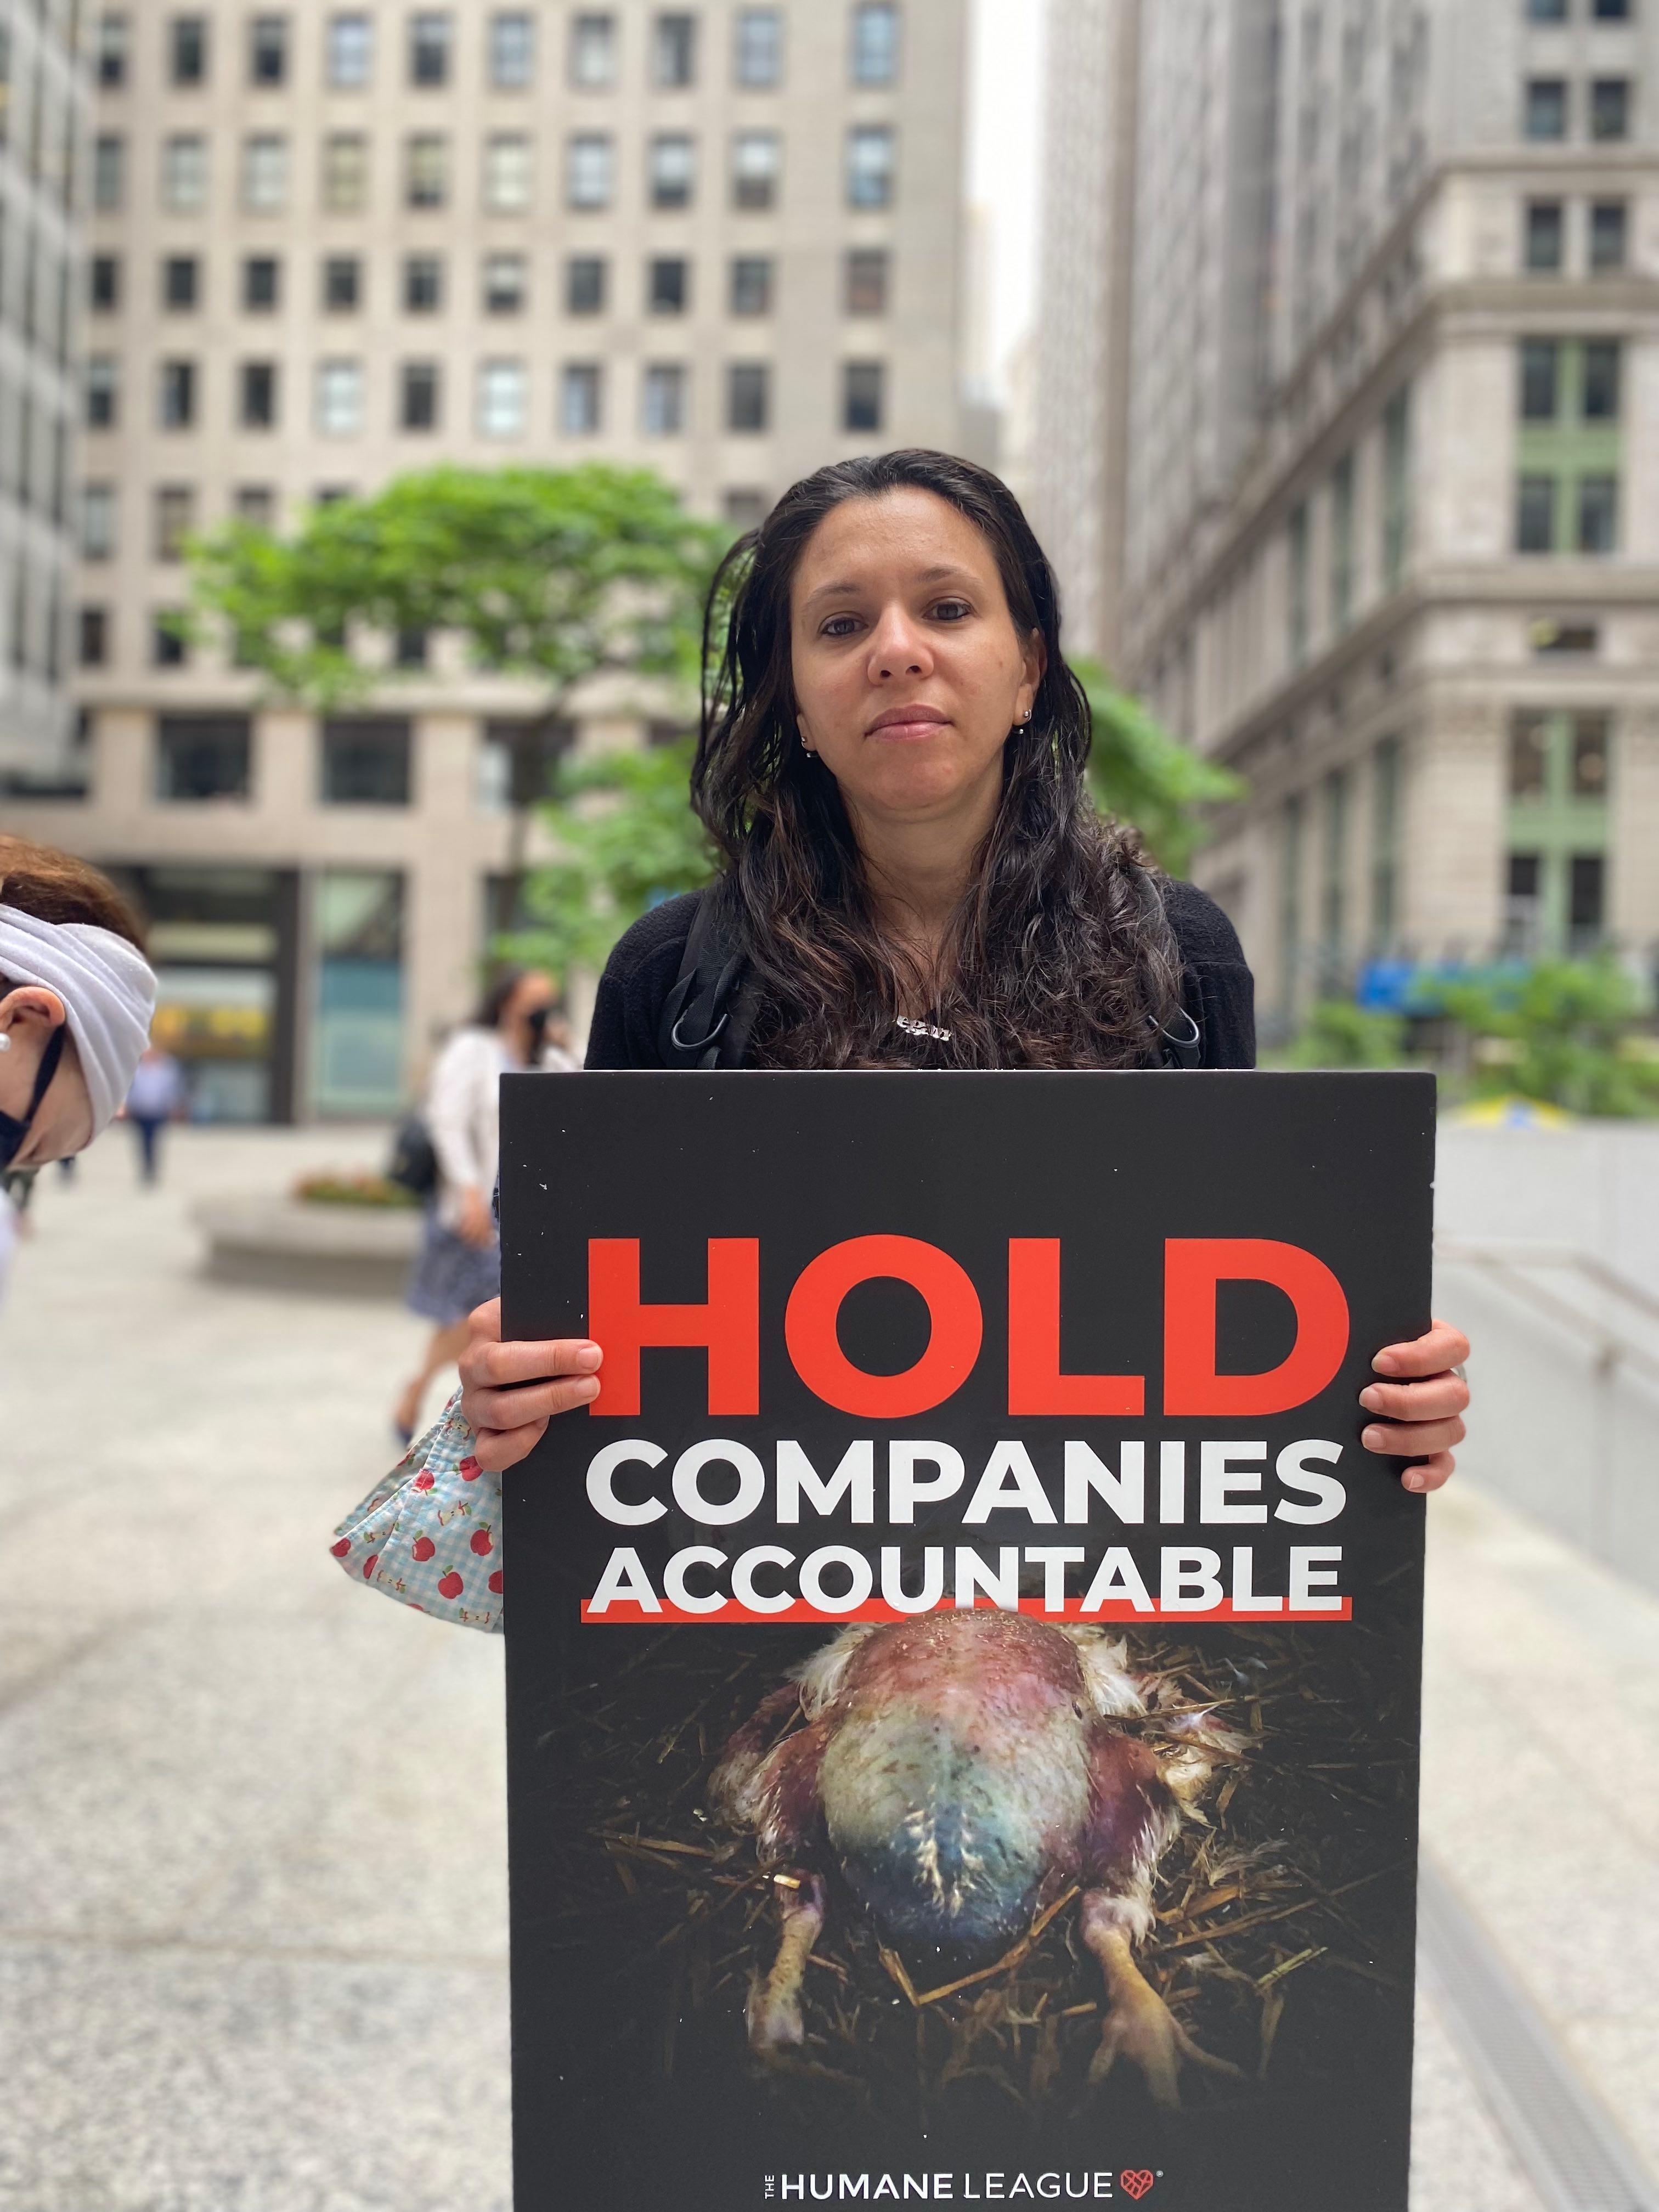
[0,1130,1659,2212]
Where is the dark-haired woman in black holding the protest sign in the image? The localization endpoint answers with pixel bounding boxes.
[336,452,1469,1626]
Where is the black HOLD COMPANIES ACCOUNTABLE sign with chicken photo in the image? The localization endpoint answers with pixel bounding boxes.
[502,1073,1434,2212]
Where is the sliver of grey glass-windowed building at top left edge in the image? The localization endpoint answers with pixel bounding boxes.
[0,0,91,792]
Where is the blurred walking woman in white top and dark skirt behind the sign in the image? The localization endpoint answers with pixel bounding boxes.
[392,969,577,1444]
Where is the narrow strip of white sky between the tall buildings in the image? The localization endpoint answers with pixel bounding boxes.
[967,0,1053,400]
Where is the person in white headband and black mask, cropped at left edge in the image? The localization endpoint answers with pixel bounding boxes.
[0,836,155,1288]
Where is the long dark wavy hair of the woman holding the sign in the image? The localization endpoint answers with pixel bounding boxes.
[692,449,1179,1068]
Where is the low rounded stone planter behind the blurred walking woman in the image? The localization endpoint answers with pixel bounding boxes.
[195,1197,425,1299]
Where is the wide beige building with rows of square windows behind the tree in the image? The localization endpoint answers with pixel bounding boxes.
[9,0,964,1117]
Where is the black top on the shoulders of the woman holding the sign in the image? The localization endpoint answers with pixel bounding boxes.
[586,883,1256,1068]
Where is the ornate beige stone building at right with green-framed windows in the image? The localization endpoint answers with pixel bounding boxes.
[1040,0,1659,1033]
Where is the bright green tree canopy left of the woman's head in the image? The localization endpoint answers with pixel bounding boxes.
[190,462,728,712]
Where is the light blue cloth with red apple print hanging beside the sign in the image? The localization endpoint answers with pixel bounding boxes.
[332,1391,502,1630]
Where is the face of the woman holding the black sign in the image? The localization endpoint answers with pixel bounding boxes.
[789,487,1044,834]
